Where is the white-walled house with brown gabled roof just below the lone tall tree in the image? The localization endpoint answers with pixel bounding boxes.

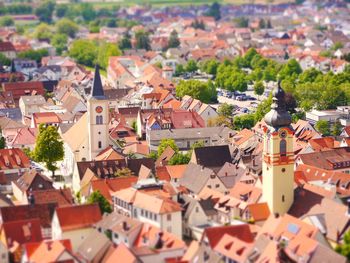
[12,169,54,203]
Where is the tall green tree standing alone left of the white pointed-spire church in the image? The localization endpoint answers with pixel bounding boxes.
[32,124,64,177]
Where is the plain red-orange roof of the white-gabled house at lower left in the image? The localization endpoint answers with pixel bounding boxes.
[56,204,102,231]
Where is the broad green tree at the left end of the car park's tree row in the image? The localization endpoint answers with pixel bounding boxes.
[176,80,217,103]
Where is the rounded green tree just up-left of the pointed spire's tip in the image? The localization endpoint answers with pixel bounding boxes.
[69,39,98,67]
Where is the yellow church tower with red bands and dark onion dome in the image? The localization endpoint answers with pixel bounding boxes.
[263,84,294,215]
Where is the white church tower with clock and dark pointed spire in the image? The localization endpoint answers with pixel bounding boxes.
[87,65,109,160]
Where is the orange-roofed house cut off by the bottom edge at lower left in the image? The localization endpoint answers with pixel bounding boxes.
[21,239,81,263]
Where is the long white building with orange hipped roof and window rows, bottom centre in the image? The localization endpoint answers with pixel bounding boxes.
[113,179,182,238]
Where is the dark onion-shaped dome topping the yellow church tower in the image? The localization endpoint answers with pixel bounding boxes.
[265,82,292,129]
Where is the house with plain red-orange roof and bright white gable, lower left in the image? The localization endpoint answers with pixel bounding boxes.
[52,204,102,251]
